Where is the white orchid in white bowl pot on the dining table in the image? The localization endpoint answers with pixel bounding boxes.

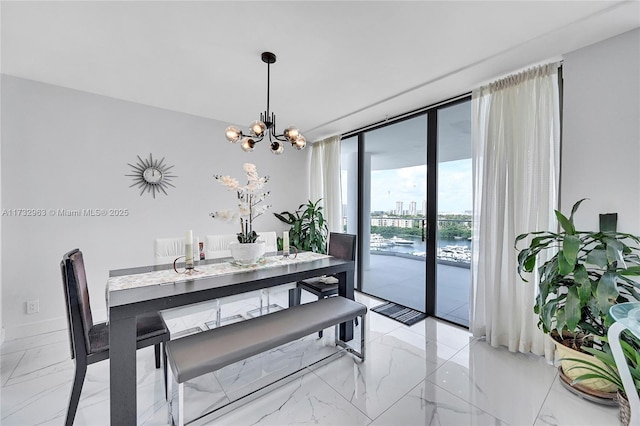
[210,163,271,264]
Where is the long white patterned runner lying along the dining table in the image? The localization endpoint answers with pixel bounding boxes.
[107,252,331,295]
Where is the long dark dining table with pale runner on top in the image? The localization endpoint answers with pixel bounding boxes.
[106,252,355,426]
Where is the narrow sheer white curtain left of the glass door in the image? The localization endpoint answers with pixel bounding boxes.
[309,136,342,232]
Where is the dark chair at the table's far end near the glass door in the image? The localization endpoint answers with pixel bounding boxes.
[289,232,358,337]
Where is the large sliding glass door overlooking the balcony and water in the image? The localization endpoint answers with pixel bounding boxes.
[341,98,472,326]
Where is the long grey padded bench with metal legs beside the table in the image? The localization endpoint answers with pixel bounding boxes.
[165,296,367,426]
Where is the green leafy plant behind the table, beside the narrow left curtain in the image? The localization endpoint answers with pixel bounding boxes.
[274,199,329,254]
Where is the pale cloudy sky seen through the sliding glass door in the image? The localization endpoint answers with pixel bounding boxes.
[343,158,473,213]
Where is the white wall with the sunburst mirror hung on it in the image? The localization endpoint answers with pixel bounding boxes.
[1,75,309,340]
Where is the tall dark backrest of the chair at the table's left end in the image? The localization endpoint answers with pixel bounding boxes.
[60,249,93,358]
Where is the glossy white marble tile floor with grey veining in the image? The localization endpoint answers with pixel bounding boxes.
[0,293,619,426]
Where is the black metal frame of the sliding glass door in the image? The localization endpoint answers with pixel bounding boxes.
[342,93,471,321]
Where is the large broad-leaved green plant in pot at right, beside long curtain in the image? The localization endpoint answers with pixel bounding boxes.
[515,199,640,392]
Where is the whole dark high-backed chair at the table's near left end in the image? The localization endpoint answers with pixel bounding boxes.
[60,249,169,426]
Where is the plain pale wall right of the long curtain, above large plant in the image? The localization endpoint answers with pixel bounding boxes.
[561,29,640,234]
